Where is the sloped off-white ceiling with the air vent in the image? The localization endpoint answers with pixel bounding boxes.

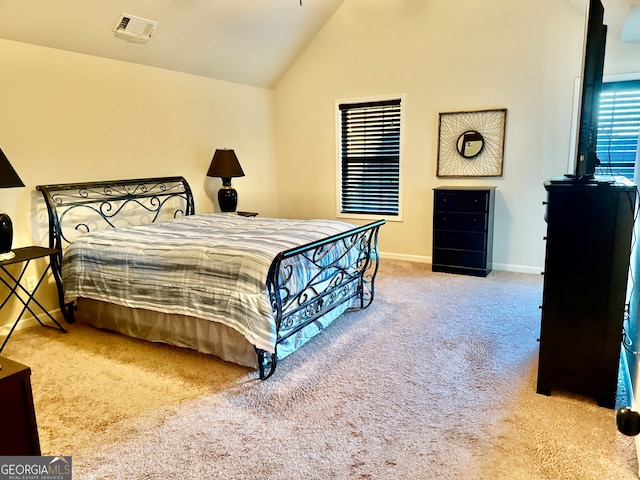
[0,0,640,88]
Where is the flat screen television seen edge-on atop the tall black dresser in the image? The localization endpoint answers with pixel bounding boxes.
[569,0,607,180]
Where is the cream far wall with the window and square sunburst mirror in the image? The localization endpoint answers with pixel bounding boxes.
[276,0,640,272]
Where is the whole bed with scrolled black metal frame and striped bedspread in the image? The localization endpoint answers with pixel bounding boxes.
[36,177,385,380]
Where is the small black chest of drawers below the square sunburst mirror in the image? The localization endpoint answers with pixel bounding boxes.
[432,187,495,277]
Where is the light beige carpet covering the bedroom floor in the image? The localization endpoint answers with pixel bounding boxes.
[3,261,638,480]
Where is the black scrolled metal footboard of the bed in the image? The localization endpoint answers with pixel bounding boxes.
[257,220,385,380]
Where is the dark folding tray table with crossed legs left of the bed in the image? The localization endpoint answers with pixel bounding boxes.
[0,246,67,352]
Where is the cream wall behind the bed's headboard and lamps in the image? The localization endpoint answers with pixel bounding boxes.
[0,40,278,324]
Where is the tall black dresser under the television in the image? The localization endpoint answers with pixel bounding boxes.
[537,177,637,408]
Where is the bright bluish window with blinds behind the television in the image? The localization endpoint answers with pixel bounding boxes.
[597,80,640,180]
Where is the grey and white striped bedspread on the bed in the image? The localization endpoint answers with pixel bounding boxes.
[62,214,354,352]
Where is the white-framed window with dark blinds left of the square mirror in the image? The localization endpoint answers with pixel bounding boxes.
[338,98,402,217]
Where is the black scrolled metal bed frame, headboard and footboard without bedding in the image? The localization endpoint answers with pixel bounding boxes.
[36,177,385,380]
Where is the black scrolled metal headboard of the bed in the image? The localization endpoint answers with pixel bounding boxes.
[36,177,195,323]
